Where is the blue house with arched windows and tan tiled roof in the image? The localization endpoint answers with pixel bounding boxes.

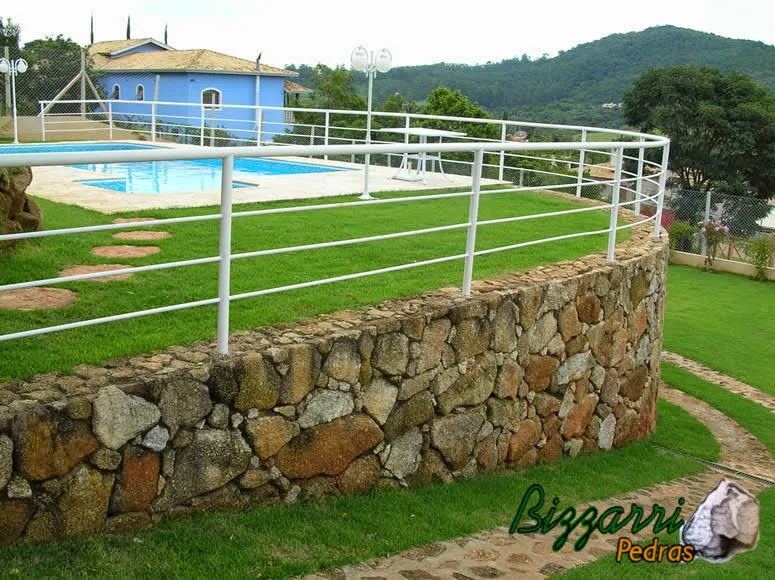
[88,38,307,141]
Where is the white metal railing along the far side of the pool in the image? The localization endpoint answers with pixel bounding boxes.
[39,100,659,197]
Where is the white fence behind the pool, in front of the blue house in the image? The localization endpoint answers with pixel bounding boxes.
[39,100,660,196]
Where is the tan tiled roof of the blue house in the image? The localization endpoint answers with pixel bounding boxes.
[89,38,299,77]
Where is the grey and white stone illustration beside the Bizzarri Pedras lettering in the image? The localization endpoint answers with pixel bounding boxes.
[679,479,759,564]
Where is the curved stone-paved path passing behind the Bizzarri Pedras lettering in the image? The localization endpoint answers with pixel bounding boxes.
[306,384,775,580]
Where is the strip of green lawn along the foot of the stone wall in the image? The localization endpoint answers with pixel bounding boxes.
[0,442,703,578]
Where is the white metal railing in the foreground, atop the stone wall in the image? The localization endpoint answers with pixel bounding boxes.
[0,135,669,354]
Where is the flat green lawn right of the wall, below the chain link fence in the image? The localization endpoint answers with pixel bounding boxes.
[664,266,775,395]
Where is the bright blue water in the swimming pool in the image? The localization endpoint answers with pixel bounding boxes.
[0,143,345,194]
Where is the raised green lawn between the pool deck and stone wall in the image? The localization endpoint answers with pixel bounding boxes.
[0,193,629,380]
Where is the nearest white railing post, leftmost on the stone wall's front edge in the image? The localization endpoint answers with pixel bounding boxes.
[217,155,234,355]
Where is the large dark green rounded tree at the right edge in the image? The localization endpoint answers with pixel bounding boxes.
[624,66,775,199]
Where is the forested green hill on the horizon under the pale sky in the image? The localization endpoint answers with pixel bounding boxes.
[288,26,775,124]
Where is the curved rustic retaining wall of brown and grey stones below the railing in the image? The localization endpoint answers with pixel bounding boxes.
[0,228,667,544]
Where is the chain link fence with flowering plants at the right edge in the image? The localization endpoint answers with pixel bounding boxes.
[662,189,775,265]
